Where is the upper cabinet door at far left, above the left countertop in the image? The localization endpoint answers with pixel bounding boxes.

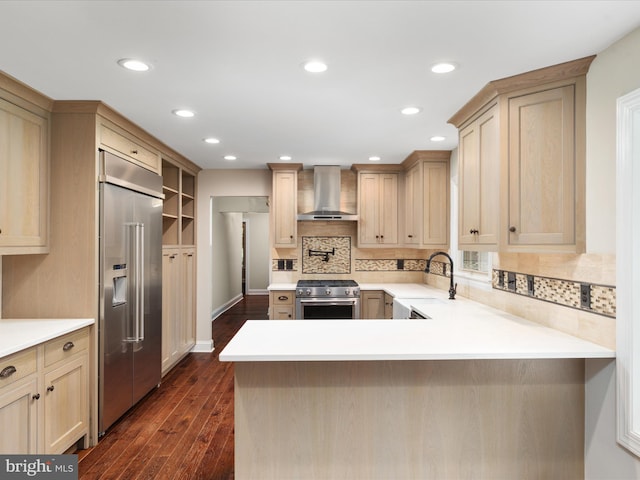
[0,99,49,254]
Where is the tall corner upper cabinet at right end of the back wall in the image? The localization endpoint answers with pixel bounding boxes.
[401,150,451,249]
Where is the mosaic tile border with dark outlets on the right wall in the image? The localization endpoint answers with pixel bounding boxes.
[491,270,616,318]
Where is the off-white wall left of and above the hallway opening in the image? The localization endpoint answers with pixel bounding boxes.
[194,169,271,352]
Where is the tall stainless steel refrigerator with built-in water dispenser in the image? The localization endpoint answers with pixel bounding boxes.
[98,152,162,435]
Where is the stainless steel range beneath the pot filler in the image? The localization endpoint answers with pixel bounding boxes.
[296,279,360,320]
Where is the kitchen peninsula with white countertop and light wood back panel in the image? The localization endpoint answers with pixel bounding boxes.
[220,292,615,479]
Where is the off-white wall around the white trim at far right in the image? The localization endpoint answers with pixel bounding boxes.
[585,29,640,480]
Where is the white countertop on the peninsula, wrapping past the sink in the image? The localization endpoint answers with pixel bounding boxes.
[220,284,615,362]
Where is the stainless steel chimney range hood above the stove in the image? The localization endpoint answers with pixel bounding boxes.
[298,165,358,221]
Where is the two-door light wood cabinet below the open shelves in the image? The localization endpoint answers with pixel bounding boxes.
[162,247,196,375]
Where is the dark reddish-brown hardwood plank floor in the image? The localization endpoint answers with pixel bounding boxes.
[78,295,269,480]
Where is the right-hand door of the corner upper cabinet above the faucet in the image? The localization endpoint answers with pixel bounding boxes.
[422,162,449,247]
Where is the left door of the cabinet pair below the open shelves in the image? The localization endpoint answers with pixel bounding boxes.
[162,248,180,373]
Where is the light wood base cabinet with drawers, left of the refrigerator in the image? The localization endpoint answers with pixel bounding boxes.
[0,328,89,454]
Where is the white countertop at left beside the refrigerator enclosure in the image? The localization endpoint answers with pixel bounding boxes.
[0,318,95,358]
